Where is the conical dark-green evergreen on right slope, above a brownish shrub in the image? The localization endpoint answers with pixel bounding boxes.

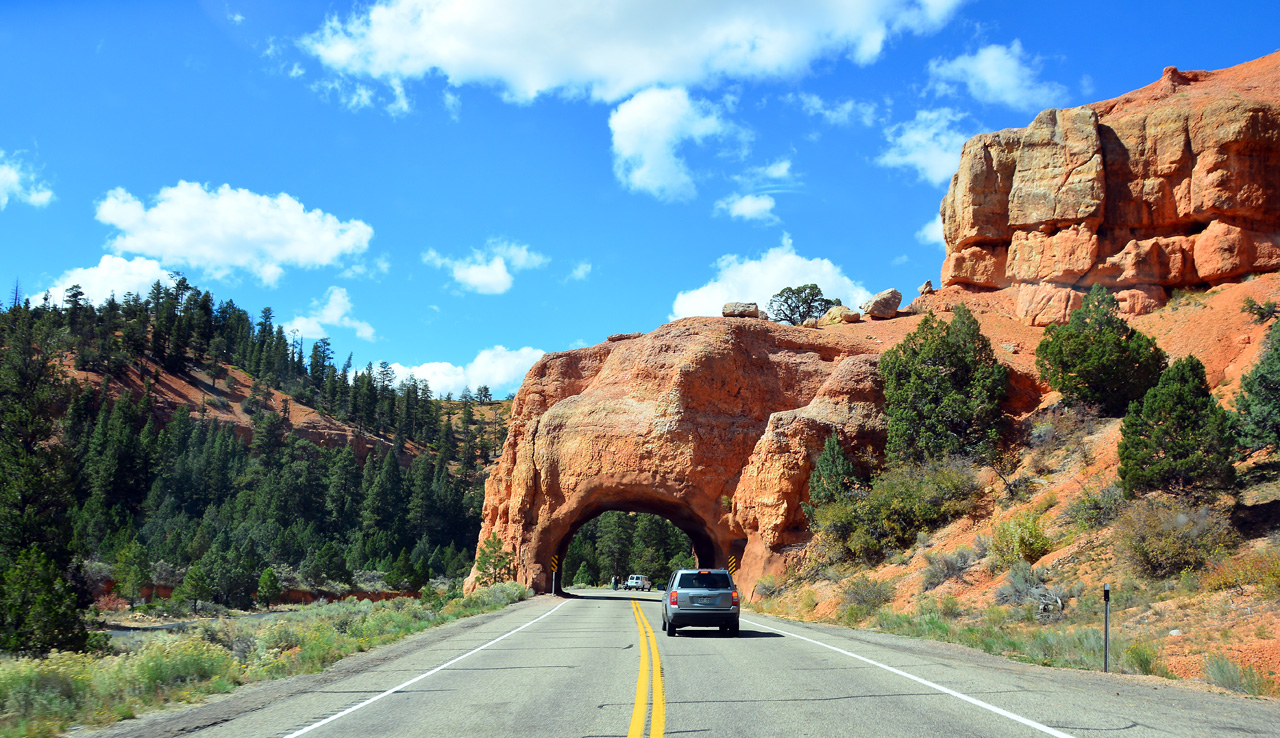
[1120,356,1235,499]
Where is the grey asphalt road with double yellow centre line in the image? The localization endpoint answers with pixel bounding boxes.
[92,590,1280,738]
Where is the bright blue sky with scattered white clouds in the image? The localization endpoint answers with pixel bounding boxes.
[0,0,1280,395]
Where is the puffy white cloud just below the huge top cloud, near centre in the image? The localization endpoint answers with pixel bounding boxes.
[609,87,739,202]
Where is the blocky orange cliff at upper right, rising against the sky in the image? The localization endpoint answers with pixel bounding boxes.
[941,52,1280,325]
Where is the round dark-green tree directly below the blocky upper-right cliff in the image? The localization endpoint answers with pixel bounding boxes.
[1036,284,1167,417]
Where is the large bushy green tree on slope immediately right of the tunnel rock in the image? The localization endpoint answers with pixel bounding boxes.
[879,304,1009,462]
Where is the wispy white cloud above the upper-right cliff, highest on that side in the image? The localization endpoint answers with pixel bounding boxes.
[929,38,1066,110]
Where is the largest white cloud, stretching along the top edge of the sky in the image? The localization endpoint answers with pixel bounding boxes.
[300,0,963,102]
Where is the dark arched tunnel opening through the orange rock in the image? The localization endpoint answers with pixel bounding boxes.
[554,500,724,595]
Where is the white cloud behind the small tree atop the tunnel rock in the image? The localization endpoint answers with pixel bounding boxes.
[669,233,870,320]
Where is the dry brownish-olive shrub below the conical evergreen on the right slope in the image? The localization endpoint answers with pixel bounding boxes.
[1116,499,1239,577]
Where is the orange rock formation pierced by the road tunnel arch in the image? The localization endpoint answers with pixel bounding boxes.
[480,318,884,592]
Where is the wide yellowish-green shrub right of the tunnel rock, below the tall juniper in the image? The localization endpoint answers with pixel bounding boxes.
[813,459,980,561]
